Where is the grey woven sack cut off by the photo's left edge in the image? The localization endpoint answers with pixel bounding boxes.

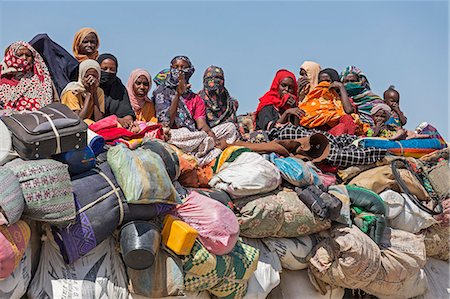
[0,166,25,225]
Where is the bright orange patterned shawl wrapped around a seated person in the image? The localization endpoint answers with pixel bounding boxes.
[299,81,346,128]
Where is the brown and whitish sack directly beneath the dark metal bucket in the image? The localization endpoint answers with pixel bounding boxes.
[127,248,184,298]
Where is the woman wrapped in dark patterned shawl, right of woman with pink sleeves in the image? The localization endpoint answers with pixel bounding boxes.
[198,66,238,128]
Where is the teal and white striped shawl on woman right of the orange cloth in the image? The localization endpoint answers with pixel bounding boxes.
[345,82,384,126]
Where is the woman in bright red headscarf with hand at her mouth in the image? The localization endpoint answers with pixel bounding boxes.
[255,70,305,130]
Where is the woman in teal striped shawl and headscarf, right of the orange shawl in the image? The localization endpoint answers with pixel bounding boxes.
[341,66,383,127]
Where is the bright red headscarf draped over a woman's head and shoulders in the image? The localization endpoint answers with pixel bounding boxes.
[255,70,298,117]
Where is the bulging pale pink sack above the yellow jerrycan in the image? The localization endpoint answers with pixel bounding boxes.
[171,191,239,255]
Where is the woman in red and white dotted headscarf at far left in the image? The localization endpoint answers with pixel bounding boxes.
[0,41,53,111]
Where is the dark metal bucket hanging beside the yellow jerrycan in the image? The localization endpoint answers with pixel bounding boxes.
[120,221,161,270]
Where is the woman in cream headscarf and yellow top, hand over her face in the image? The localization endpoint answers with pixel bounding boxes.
[61,59,105,122]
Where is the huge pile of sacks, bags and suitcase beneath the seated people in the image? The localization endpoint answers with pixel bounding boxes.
[0,103,450,299]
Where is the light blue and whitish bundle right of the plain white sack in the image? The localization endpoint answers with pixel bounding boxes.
[271,155,322,187]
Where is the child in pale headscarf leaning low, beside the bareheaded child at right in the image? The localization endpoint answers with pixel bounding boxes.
[367,103,430,141]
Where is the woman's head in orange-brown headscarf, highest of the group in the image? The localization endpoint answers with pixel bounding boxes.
[72,28,100,62]
